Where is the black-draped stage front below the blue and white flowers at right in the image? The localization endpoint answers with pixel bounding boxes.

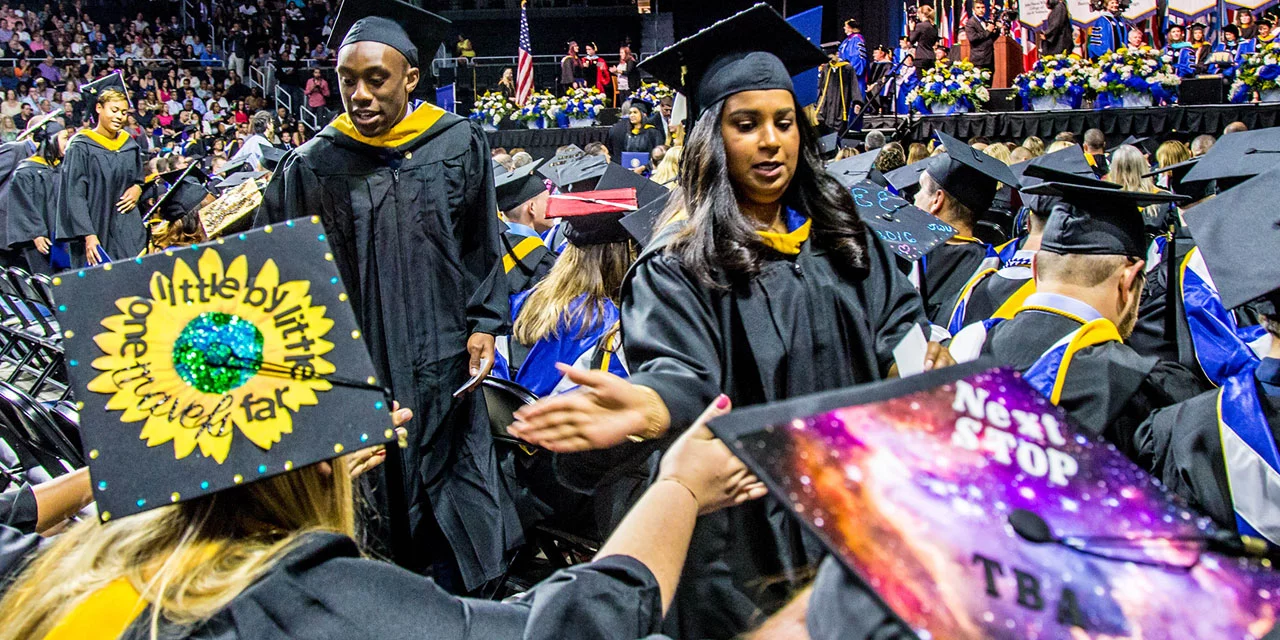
[865,102,1280,142]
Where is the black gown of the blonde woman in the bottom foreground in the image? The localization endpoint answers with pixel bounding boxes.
[122,534,662,640]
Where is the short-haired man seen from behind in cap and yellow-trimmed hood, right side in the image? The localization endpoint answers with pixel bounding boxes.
[951,166,1201,457]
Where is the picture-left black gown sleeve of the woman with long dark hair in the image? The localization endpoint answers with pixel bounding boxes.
[622,255,724,433]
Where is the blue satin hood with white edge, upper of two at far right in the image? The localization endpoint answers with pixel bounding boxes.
[1179,248,1266,387]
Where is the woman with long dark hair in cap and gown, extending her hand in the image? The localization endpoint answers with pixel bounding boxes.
[511,5,943,637]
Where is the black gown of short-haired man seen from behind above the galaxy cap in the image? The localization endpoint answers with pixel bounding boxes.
[982,311,1203,457]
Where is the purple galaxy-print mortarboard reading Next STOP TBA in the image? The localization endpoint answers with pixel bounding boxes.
[710,362,1280,640]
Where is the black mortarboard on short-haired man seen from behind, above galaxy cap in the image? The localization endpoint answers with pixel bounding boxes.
[1023,182,1185,257]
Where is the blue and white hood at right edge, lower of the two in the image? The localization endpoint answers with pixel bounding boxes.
[1217,371,1280,544]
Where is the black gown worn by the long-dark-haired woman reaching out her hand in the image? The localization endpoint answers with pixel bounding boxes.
[622,224,925,637]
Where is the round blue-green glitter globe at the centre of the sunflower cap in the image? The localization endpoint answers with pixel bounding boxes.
[173,311,262,394]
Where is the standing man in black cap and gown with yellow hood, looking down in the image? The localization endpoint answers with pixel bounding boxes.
[255,0,520,593]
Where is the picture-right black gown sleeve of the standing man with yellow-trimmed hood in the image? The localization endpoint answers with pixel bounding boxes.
[453,123,511,335]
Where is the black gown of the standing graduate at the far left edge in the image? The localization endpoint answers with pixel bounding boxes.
[5,160,61,274]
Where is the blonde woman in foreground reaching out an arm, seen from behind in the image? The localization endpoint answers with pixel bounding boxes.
[0,396,764,640]
